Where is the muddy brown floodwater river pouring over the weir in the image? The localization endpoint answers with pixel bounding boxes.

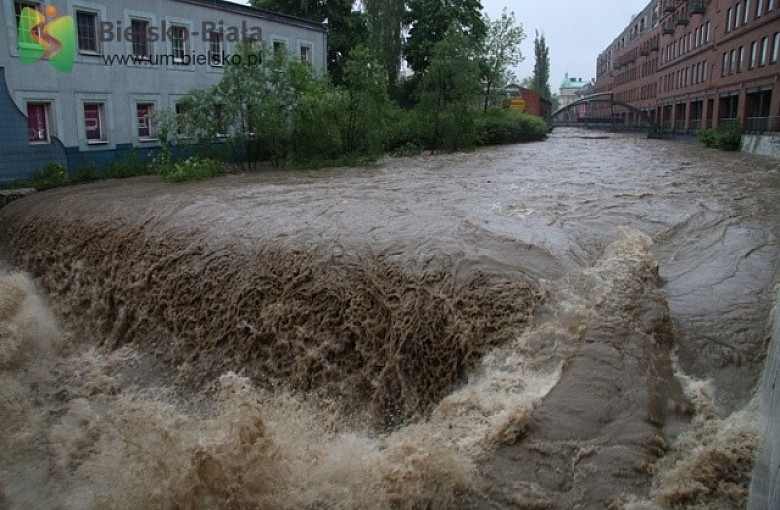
[0,130,780,510]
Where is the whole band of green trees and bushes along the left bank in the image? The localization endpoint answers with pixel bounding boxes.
[9,0,549,189]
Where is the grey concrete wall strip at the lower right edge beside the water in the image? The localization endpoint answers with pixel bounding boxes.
[748,286,780,510]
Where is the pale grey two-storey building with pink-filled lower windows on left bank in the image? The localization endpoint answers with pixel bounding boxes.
[0,0,327,182]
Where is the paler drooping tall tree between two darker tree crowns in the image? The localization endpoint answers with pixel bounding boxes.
[363,0,406,89]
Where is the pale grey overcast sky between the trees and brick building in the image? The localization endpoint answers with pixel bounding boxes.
[233,0,649,92]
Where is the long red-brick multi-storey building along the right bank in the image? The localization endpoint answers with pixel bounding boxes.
[596,0,780,132]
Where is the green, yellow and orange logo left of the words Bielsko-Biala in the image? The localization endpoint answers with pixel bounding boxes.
[19,5,76,73]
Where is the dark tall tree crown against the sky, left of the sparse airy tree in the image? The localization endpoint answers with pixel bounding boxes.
[404,0,487,73]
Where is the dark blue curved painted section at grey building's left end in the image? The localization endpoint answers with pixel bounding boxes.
[0,67,68,183]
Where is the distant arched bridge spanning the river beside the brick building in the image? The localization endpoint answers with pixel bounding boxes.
[552,92,658,132]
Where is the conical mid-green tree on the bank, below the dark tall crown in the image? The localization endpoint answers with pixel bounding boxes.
[417,25,482,152]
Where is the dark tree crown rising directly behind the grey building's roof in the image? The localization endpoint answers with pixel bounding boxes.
[249,0,368,84]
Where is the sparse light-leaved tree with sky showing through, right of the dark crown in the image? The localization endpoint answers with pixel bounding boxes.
[480,8,525,111]
